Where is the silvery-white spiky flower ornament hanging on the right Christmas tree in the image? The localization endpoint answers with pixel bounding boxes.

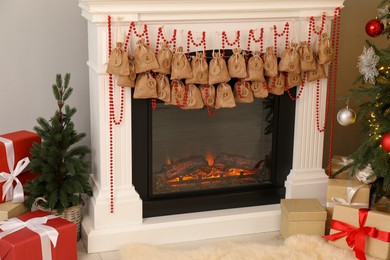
[358,46,379,84]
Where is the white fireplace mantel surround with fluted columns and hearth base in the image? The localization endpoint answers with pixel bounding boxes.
[79,0,344,253]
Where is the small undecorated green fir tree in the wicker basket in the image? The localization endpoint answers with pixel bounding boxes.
[25,74,92,213]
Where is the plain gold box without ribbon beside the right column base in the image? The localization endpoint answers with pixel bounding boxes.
[280,199,326,238]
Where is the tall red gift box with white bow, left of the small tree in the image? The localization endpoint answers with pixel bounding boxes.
[0,130,41,202]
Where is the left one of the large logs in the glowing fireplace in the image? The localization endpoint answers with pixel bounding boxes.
[163,156,208,180]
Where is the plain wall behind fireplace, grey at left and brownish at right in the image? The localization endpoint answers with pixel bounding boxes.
[0,0,386,165]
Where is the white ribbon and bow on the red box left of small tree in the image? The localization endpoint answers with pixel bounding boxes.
[0,137,30,203]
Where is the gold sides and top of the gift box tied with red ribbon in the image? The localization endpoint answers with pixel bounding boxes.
[329,205,390,259]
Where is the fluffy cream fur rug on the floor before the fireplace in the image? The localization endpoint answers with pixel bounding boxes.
[120,235,362,260]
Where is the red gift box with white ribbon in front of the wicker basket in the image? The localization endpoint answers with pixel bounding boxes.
[0,210,77,260]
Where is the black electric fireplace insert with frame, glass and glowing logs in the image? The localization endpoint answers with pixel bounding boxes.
[132,88,295,217]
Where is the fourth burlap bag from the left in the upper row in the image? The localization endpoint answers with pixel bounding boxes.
[171,47,192,80]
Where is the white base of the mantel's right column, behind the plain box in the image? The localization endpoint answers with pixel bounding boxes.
[285,169,328,204]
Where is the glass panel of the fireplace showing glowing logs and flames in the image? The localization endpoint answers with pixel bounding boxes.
[152,95,274,196]
